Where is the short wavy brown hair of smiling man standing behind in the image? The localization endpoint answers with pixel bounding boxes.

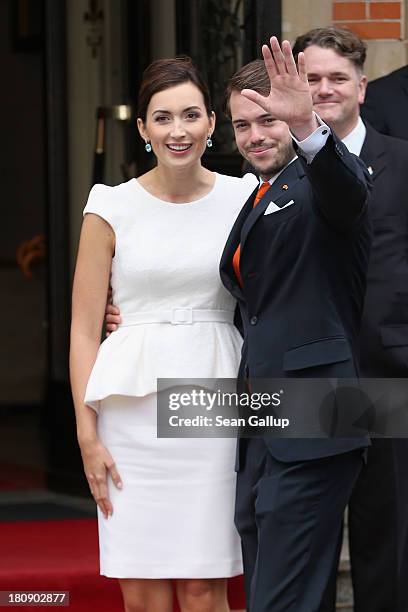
[292,26,367,72]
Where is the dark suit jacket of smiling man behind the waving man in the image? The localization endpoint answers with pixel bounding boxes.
[360,122,408,378]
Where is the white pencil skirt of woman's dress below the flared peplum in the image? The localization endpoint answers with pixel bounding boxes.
[98,394,242,578]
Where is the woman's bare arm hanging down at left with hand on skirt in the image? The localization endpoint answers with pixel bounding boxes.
[70,214,121,517]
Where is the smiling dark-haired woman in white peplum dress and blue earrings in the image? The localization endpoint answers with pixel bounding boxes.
[71,58,257,612]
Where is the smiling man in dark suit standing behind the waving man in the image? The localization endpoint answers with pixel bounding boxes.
[293,28,408,612]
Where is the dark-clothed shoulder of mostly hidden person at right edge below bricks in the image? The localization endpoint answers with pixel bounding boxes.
[361,66,408,140]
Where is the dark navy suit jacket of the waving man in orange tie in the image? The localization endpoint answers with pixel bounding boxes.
[220,134,371,461]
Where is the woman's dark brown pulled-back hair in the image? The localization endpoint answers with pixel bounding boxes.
[137,55,212,123]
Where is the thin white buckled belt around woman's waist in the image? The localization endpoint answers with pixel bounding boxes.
[120,308,234,327]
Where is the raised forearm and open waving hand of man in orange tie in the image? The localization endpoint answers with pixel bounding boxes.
[241,36,371,230]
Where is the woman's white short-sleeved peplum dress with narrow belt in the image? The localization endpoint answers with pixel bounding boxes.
[84,174,258,578]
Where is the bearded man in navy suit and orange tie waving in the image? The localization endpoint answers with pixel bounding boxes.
[220,38,371,612]
